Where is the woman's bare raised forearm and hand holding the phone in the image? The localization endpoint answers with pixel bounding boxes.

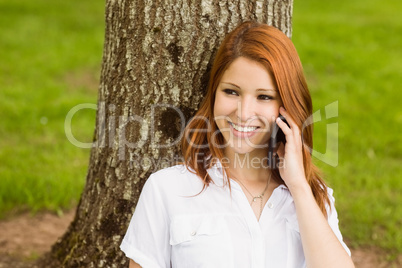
[276,107,354,267]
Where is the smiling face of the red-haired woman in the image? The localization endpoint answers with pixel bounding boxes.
[214,57,282,155]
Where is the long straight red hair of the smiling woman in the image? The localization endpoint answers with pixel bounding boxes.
[182,22,329,215]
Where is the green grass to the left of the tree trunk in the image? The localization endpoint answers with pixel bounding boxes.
[0,0,104,218]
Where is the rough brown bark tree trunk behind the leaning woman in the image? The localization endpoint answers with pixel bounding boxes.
[38,0,293,267]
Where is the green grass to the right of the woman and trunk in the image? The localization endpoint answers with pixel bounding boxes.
[292,0,402,254]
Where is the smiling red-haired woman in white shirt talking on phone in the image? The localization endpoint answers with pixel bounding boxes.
[121,22,354,268]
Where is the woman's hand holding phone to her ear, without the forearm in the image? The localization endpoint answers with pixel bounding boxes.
[276,107,308,192]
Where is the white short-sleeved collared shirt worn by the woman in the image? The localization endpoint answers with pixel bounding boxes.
[120,165,350,268]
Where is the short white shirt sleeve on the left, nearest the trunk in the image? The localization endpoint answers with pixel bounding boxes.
[120,175,170,268]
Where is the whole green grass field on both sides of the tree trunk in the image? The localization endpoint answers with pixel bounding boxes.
[0,0,402,257]
